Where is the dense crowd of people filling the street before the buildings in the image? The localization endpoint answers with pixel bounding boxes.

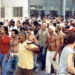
[0,16,75,75]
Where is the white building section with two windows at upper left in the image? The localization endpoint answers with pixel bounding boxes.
[0,0,30,19]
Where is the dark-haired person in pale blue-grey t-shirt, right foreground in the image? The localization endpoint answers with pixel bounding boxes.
[57,33,75,75]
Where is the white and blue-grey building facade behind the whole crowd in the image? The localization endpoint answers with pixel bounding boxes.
[0,0,75,19]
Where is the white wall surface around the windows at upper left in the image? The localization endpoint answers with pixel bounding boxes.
[2,0,29,18]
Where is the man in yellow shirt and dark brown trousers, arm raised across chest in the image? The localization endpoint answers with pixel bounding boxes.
[16,32,39,75]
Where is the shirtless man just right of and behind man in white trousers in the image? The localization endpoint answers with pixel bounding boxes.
[55,26,64,56]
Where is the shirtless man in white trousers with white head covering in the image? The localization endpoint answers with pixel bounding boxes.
[46,26,59,75]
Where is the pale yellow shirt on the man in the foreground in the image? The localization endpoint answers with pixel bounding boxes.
[18,41,37,69]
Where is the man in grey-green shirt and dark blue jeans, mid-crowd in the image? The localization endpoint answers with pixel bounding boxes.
[36,23,49,70]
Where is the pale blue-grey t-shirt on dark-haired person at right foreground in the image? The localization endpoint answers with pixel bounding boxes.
[57,46,75,75]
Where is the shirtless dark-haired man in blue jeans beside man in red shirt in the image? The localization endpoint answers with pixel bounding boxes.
[5,29,19,75]
